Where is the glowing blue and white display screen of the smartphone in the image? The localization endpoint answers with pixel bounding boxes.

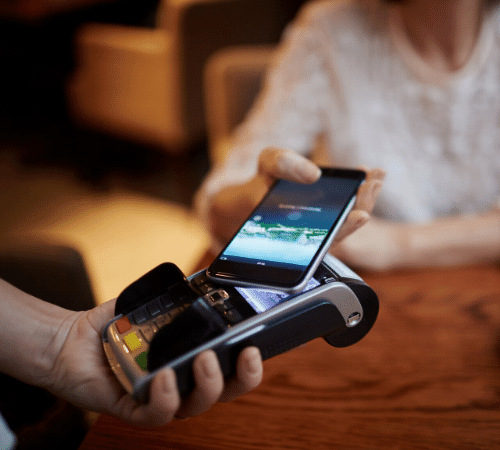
[220,177,359,270]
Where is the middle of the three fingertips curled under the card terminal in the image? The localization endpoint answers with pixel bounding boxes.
[175,350,224,419]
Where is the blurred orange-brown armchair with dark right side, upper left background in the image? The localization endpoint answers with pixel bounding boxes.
[67,0,304,153]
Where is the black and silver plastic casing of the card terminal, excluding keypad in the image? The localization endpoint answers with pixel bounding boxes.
[103,255,379,402]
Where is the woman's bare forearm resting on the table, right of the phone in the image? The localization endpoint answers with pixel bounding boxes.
[331,208,500,271]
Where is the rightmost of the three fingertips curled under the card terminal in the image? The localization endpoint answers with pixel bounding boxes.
[219,347,264,402]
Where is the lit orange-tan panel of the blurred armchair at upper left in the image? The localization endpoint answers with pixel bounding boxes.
[67,24,181,152]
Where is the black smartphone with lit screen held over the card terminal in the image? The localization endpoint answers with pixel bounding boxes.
[207,168,366,293]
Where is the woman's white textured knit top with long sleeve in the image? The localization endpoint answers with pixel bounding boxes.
[198,0,500,222]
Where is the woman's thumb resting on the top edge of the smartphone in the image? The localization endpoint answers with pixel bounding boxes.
[258,147,321,185]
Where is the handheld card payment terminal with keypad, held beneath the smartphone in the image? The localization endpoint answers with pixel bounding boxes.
[103,255,379,402]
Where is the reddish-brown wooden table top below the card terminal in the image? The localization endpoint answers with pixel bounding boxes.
[81,256,500,450]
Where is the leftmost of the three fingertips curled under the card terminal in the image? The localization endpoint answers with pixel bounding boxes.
[124,369,181,427]
